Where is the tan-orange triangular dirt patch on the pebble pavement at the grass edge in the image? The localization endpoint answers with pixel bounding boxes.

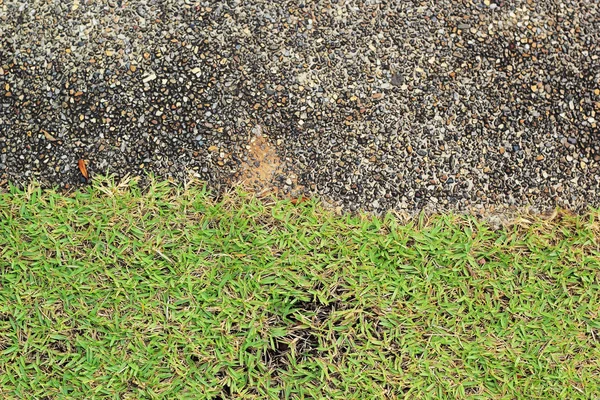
[236,125,303,197]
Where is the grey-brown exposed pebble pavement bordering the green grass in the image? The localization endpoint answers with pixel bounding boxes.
[0,0,600,211]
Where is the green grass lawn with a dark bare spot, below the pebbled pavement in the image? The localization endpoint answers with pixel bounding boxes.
[0,180,600,400]
